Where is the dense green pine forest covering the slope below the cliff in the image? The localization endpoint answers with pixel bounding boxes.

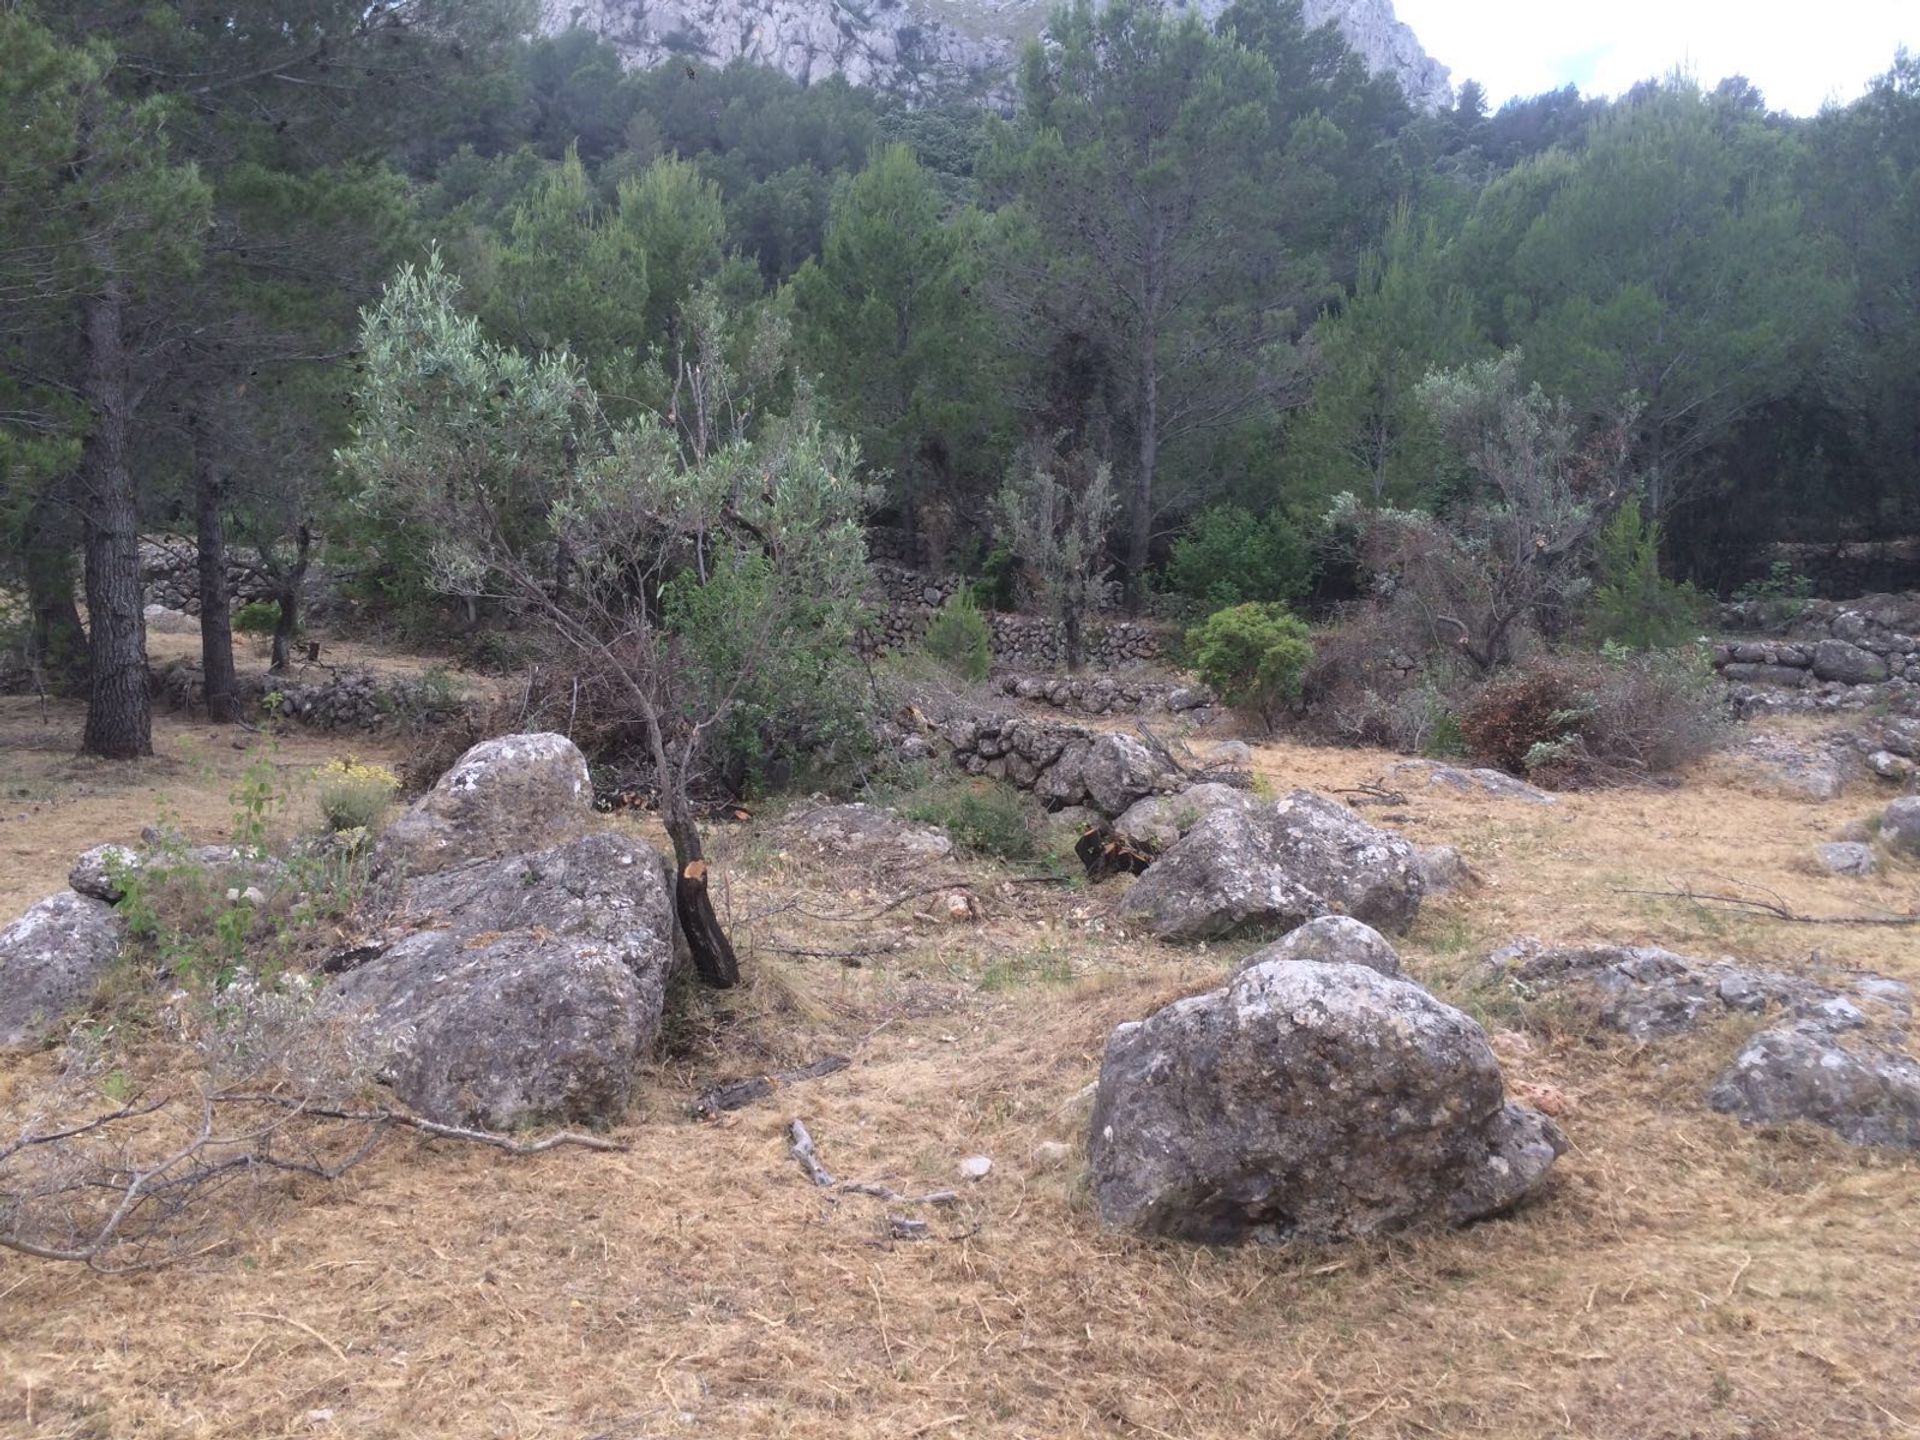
[0,0,1920,768]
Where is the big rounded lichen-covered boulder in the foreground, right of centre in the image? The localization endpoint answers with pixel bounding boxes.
[1089,960,1565,1244]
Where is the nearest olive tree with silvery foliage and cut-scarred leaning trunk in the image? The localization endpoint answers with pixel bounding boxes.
[340,255,868,983]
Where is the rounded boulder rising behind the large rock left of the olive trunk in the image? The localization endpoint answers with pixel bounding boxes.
[372,733,593,877]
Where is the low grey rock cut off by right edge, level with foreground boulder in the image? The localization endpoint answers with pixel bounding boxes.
[1707,1021,1920,1150]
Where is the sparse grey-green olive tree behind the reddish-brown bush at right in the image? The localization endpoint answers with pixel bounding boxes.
[1332,351,1636,674]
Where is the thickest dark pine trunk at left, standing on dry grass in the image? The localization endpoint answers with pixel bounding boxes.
[81,280,154,760]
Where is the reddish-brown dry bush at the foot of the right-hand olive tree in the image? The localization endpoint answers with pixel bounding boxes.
[1461,649,1726,789]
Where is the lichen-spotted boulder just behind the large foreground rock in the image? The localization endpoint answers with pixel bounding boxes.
[1119,789,1421,941]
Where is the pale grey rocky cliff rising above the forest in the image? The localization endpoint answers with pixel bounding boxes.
[541,0,1453,109]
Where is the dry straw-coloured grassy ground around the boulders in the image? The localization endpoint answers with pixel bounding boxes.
[0,695,1920,1440]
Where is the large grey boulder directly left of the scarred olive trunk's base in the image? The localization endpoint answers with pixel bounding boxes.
[332,833,674,1129]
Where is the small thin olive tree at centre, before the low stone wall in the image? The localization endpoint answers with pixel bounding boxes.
[995,444,1119,670]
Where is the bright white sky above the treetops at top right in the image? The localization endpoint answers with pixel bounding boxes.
[1394,0,1920,115]
